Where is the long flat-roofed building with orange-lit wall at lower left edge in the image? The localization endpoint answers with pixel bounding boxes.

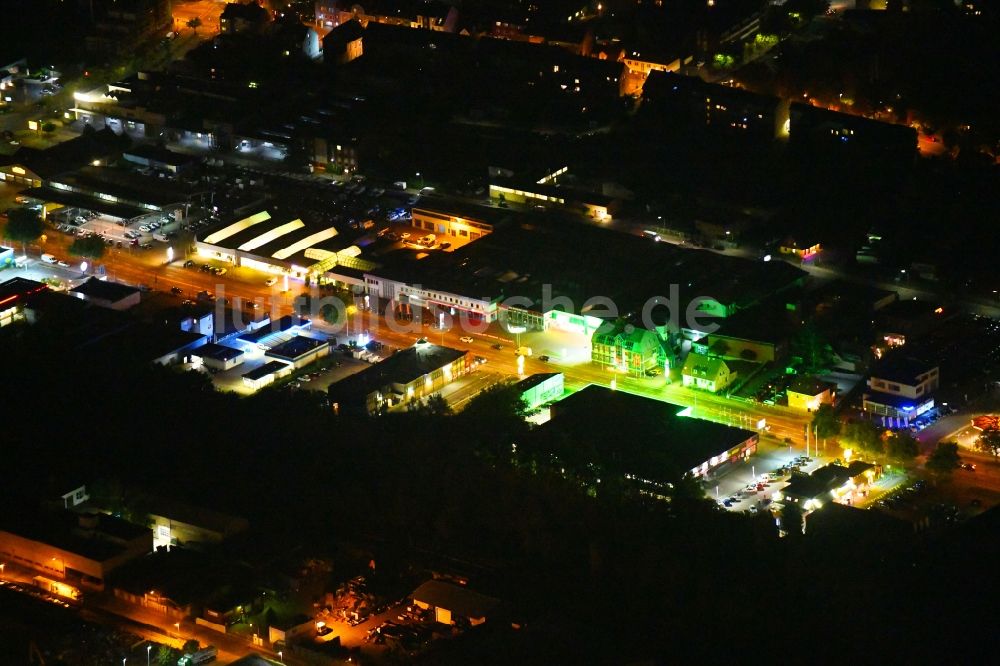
[0,500,153,589]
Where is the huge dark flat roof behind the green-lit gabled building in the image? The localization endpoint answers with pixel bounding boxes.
[369,215,805,316]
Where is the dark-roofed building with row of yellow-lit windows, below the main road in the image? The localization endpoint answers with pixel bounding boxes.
[328,340,469,415]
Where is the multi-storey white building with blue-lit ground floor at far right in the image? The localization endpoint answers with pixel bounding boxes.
[862,354,941,426]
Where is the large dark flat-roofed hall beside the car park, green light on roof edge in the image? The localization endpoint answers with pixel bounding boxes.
[518,385,759,486]
